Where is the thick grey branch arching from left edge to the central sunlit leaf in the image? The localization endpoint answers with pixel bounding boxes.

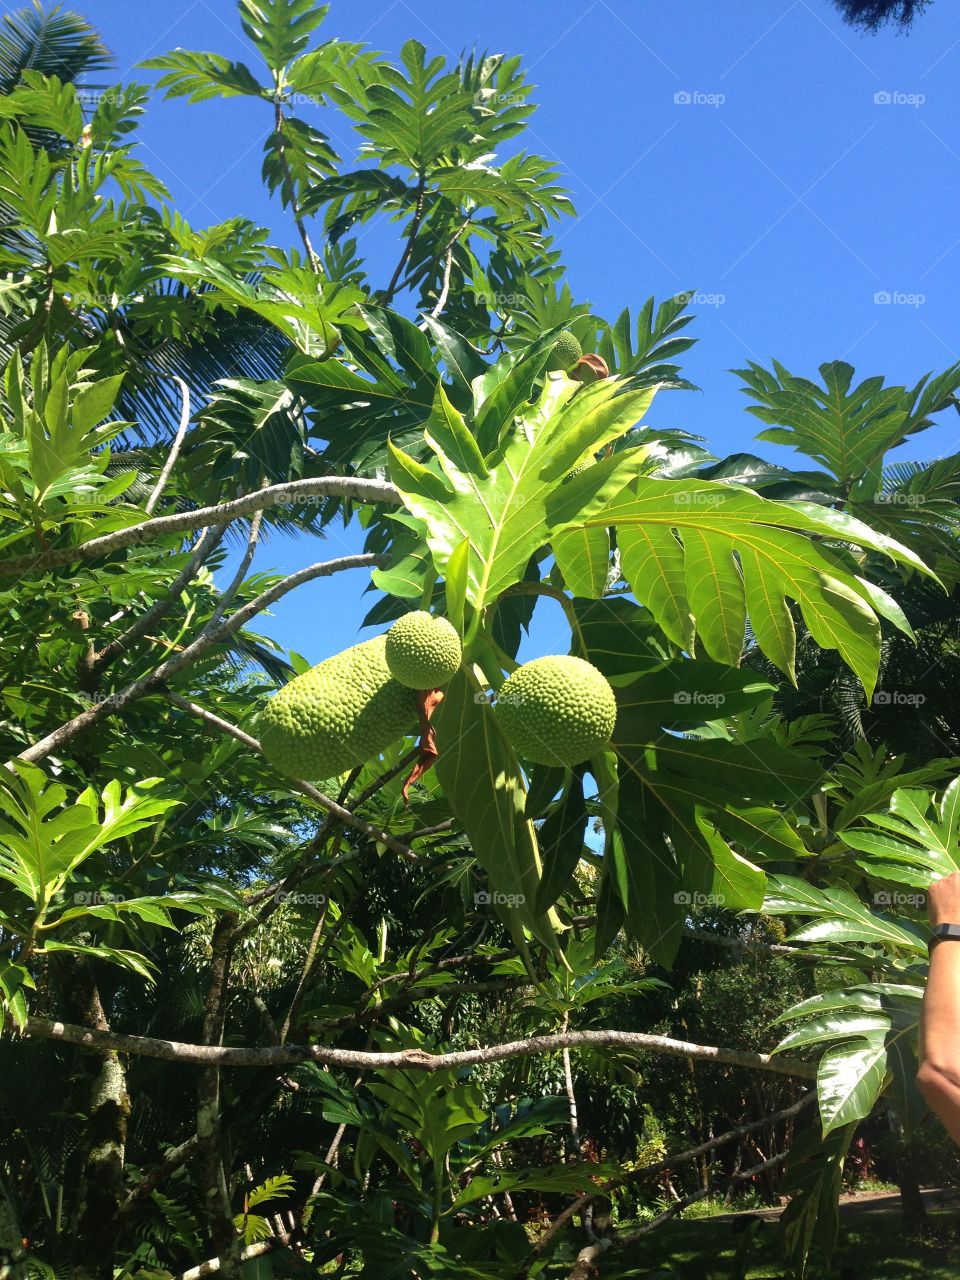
[0,476,401,575]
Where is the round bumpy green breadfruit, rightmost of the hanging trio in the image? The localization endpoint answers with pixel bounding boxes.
[494,657,617,768]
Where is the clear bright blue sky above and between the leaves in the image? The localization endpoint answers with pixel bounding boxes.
[80,0,960,660]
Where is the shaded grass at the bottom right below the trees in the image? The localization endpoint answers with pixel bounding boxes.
[548,1211,960,1280]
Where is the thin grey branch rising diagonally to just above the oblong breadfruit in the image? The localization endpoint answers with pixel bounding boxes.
[8,554,381,768]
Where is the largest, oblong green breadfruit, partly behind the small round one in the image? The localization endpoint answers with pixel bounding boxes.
[260,636,417,781]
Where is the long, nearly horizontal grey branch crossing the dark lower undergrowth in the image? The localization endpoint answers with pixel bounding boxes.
[16,1018,817,1080]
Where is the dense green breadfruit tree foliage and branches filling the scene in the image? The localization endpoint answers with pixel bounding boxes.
[0,0,960,1280]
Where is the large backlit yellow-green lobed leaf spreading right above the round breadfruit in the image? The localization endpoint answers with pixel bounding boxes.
[583,472,929,694]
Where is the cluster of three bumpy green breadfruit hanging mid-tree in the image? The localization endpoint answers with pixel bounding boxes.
[260,611,617,780]
